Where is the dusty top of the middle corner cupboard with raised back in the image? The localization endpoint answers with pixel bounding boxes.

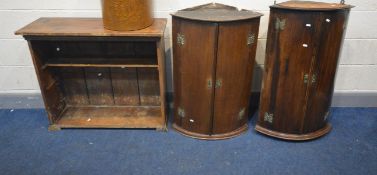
[172,3,263,22]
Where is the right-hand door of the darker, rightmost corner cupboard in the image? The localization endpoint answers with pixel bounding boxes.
[304,11,349,132]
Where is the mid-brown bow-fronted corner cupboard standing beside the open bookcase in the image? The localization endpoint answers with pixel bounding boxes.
[173,4,261,140]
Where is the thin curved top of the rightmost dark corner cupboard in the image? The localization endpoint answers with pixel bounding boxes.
[271,1,354,11]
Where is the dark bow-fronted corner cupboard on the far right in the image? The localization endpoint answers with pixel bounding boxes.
[256,2,350,140]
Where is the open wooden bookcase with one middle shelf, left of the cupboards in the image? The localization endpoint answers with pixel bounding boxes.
[16,18,166,130]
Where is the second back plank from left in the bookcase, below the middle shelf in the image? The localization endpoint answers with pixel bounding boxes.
[85,68,114,105]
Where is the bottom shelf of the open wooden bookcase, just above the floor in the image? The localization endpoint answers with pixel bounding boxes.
[49,106,166,131]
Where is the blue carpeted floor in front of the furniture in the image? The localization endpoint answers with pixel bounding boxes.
[0,108,377,175]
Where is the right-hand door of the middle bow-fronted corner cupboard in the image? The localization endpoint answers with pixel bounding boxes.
[212,19,259,134]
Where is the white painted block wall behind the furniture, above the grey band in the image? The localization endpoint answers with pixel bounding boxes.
[0,0,377,93]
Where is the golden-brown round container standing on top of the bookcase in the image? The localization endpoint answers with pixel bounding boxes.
[102,0,153,31]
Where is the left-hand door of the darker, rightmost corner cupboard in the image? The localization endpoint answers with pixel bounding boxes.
[258,10,317,134]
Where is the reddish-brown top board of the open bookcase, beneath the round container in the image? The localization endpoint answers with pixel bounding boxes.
[15,18,167,37]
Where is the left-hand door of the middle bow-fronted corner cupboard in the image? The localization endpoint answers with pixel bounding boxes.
[173,18,217,134]
